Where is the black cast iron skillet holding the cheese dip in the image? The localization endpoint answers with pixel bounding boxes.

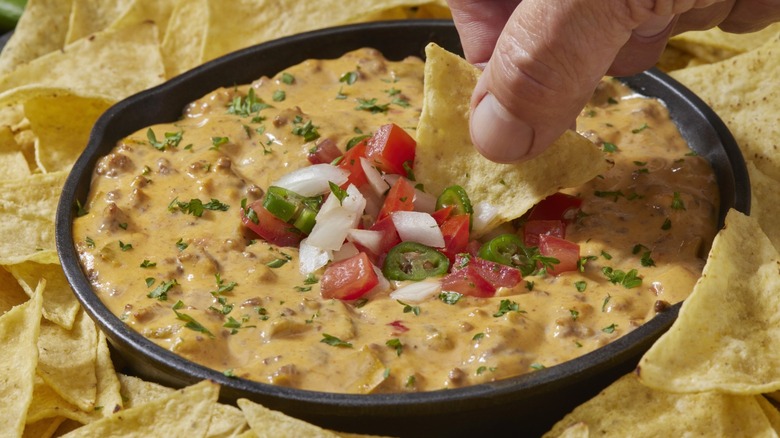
[56,20,750,436]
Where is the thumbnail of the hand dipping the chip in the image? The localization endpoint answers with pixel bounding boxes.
[469,93,534,163]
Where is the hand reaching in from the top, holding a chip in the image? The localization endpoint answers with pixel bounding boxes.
[448,0,780,163]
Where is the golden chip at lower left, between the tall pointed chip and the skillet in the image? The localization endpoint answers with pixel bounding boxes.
[37,309,97,411]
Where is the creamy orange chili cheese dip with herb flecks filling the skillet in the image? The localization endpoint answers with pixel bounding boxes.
[73,49,718,393]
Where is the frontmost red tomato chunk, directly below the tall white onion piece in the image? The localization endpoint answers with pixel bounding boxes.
[320,252,379,300]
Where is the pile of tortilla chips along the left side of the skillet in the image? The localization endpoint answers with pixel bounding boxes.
[0,0,449,438]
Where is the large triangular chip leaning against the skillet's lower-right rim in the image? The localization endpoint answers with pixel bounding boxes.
[637,210,780,394]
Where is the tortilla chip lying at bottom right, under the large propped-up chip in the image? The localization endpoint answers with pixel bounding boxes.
[544,374,773,438]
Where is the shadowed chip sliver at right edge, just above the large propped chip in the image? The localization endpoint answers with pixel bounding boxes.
[746,161,780,251]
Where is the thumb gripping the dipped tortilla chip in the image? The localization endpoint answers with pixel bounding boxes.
[470,0,673,163]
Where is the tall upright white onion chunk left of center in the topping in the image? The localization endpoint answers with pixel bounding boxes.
[307,184,366,251]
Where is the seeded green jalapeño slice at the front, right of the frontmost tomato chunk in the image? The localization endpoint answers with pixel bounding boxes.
[382,242,450,281]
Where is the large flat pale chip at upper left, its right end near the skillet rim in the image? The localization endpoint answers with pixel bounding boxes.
[0,22,165,102]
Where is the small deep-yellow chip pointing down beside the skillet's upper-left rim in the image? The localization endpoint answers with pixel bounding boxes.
[24,92,113,173]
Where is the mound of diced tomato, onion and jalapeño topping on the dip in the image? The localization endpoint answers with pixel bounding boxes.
[241,123,582,301]
